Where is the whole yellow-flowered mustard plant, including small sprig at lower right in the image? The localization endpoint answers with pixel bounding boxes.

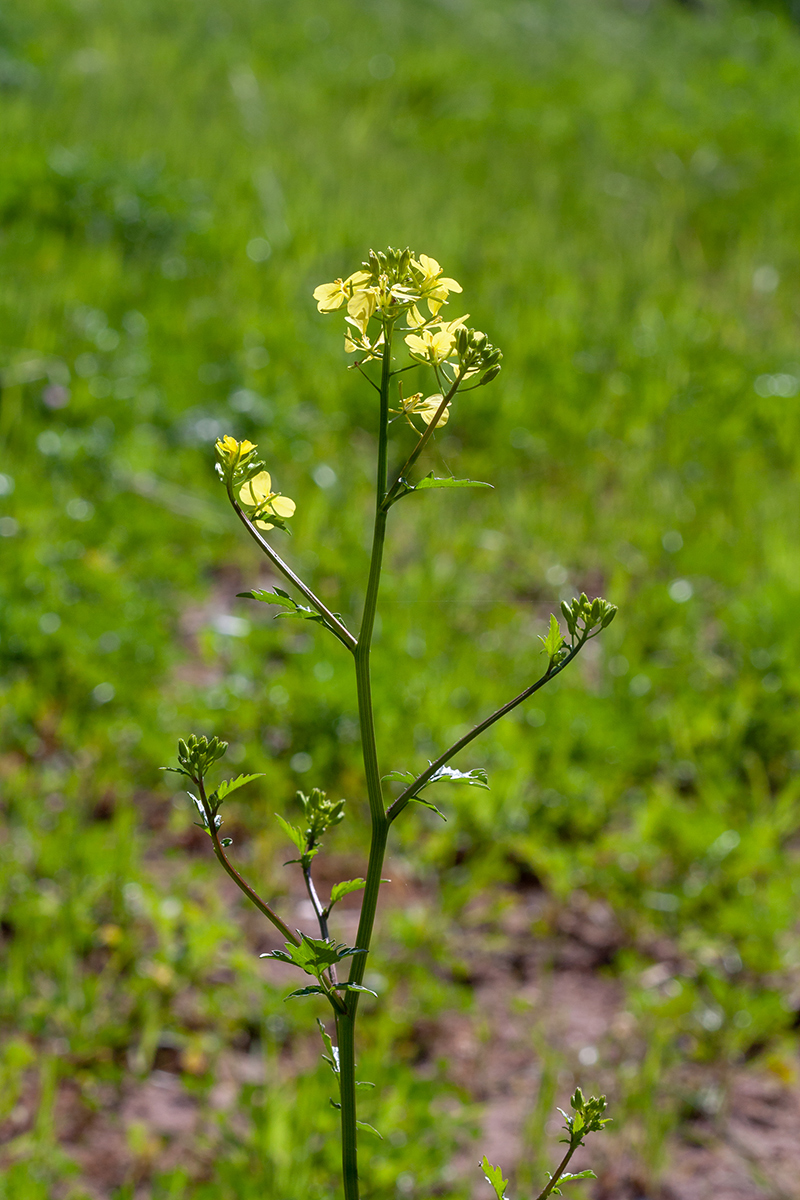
[166,248,616,1200]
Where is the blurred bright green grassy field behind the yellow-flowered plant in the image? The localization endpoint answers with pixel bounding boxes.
[0,0,800,1200]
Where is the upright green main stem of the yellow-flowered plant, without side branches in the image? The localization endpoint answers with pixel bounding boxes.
[337,325,392,1200]
